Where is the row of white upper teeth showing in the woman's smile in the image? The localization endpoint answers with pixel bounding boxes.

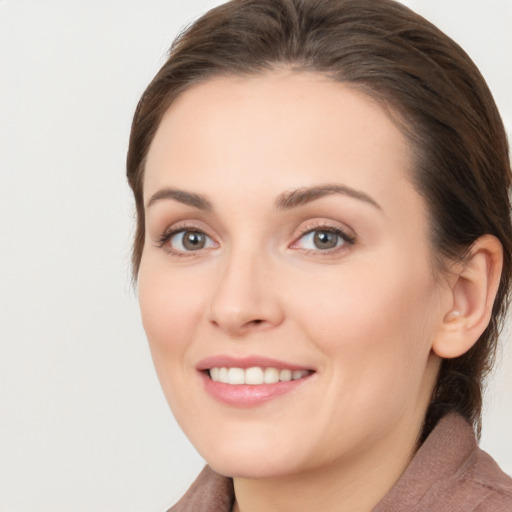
[210,366,310,386]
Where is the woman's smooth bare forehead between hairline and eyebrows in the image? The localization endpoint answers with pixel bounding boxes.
[144,71,420,216]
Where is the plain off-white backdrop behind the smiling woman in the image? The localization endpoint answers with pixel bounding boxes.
[0,0,512,512]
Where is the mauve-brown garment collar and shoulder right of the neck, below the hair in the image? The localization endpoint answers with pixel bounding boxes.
[374,414,512,512]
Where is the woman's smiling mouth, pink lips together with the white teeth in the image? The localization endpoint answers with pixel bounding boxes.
[196,356,315,407]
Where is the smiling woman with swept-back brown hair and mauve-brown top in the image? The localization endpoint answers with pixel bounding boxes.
[128,0,512,512]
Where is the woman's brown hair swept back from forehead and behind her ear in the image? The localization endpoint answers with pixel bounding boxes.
[127,0,512,436]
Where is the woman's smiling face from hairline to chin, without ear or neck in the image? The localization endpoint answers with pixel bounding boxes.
[139,72,446,477]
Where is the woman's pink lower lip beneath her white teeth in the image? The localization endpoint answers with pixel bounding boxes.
[201,372,311,407]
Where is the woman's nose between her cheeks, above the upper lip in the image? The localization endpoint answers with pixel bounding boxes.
[209,247,284,337]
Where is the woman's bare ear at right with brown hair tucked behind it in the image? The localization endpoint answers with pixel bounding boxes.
[432,235,503,358]
